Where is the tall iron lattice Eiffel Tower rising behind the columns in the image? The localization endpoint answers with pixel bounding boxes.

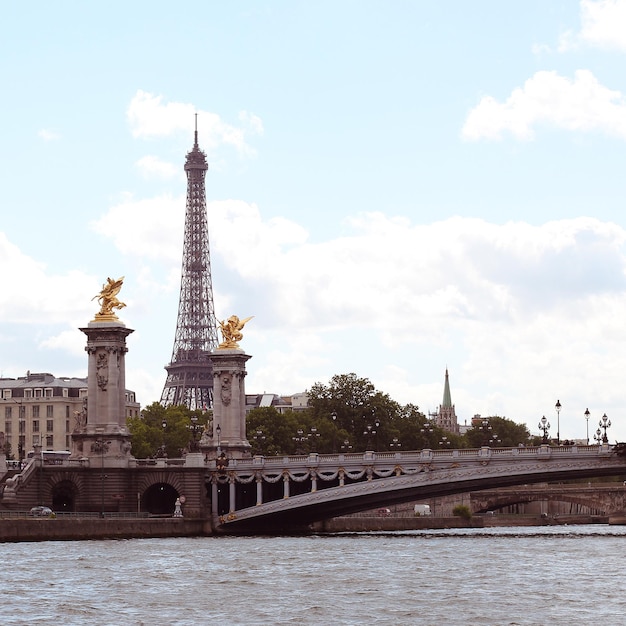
[161,117,218,410]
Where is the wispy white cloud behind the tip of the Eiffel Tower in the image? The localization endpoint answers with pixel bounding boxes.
[126,90,263,157]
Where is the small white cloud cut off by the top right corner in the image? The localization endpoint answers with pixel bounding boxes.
[559,0,626,52]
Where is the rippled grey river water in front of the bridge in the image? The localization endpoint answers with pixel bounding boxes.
[0,525,626,626]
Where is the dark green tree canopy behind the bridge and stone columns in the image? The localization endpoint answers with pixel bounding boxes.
[128,373,540,458]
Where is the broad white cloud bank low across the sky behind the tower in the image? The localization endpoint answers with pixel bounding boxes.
[7,205,626,438]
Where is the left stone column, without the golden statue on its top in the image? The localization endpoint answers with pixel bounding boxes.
[72,320,133,467]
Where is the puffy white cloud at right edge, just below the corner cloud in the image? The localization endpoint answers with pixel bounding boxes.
[462,70,626,141]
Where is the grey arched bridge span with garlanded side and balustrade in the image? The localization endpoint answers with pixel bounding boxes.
[208,446,626,533]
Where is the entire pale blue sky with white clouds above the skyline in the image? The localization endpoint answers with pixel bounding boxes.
[0,0,626,441]
